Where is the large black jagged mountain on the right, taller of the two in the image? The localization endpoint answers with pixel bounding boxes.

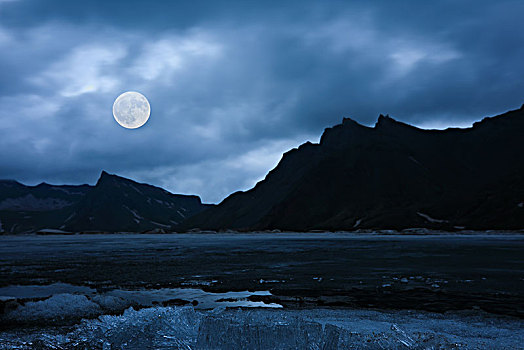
[179,106,524,231]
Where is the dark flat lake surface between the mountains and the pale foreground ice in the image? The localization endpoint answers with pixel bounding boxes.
[0,233,524,319]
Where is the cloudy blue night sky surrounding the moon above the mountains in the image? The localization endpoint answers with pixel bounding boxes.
[0,0,524,202]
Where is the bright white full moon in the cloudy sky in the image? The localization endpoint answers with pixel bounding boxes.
[113,91,151,129]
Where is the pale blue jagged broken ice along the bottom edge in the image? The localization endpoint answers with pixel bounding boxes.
[0,306,524,350]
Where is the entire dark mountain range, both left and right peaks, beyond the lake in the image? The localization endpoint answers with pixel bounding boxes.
[0,106,524,233]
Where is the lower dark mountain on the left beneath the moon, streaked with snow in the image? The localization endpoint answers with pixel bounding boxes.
[0,171,208,233]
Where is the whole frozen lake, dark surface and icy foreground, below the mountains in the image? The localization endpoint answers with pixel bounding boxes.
[0,233,524,349]
